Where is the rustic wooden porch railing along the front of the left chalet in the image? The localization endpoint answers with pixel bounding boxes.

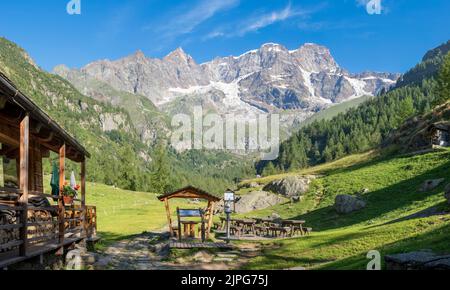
[0,192,97,267]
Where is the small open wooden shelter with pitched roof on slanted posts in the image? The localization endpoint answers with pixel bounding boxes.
[158,186,221,237]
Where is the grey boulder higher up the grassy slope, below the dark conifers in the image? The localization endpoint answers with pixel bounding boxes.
[263,176,314,197]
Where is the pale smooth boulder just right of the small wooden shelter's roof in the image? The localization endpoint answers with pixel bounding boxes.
[236,191,285,213]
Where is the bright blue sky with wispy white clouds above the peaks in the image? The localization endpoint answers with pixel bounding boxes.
[0,0,450,72]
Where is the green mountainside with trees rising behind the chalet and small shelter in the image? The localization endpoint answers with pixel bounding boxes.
[0,38,254,191]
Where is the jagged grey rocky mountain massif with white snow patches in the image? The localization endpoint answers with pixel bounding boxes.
[55,43,399,121]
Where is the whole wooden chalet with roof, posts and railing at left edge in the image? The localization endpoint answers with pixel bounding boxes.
[0,73,96,268]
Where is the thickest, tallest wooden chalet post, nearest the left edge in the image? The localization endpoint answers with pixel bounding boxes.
[19,114,30,256]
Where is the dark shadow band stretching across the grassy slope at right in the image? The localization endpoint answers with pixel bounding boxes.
[293,159,450,231]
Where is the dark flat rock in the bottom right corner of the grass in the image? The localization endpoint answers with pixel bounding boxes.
[384,250,450,270]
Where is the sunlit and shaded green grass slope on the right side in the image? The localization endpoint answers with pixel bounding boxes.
[239,150,450,269]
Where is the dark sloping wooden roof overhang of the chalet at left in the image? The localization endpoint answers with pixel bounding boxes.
[0,72,90,161]
